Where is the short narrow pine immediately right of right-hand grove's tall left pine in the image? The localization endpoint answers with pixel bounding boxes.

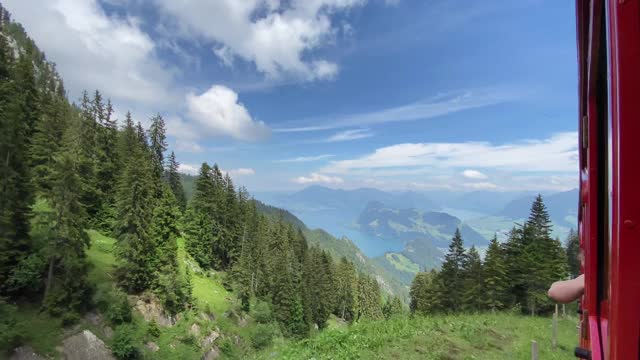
[462,246,486,311]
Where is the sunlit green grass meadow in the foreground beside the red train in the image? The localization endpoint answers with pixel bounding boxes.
[255,313,578,360]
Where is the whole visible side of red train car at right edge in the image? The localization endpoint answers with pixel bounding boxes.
[576,0,640,360]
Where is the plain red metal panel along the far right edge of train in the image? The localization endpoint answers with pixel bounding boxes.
[608,0,640,360]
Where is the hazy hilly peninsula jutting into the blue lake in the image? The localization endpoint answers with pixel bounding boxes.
[357,201,488,248]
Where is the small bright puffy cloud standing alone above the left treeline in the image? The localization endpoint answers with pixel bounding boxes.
[180,85,271,141]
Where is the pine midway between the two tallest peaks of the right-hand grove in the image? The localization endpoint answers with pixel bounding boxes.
[483,236,509,311]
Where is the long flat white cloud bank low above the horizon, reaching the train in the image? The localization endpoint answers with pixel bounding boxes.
[322,132,578,173]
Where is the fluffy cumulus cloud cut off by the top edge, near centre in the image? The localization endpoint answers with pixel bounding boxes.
[155,0,365,80]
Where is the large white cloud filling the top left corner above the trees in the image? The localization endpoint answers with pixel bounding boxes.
[3,0,175,104]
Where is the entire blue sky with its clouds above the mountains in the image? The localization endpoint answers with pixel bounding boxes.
[4,0,577,191]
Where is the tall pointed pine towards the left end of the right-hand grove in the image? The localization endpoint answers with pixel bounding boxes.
[440,229,466,312]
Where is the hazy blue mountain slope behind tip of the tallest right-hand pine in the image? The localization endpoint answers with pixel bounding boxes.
[497,189,578,227]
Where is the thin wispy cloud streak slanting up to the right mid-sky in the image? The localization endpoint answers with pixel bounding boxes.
[274,88,522,133]
